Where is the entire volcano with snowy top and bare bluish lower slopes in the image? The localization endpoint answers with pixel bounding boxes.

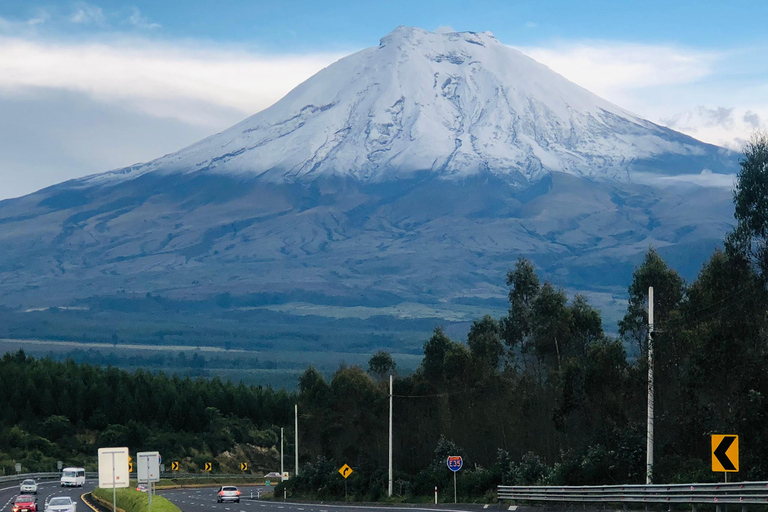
[0,27,737,320]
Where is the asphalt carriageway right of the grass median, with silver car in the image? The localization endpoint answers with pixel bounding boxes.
[157,487,484,512]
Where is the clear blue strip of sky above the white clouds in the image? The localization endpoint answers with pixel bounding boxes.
[2,0,768,51]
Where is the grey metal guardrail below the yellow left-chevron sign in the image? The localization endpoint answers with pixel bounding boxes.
[498,482,768,510]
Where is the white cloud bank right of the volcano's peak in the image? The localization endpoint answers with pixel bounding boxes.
[519,41,768,150]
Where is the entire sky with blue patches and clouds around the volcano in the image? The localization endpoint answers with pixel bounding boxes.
[0,0,768,199]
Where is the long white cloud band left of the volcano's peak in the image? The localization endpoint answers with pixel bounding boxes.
[0,38,341,129]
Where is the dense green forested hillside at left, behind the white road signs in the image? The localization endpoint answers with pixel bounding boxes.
[0,352,294,473]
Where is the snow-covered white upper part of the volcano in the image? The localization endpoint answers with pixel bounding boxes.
[89,27,728,186]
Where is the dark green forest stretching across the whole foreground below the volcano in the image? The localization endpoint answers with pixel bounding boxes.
[0,138,768,500]
